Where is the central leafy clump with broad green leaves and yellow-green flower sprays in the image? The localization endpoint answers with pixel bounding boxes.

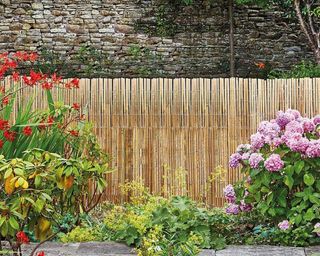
[104,185,228,255]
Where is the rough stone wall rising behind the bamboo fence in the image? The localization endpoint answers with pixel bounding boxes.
[0,0,312,77]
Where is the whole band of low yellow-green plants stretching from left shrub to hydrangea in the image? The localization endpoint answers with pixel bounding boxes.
[60,182,290,256]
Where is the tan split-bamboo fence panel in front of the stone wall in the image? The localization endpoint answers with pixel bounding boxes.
[5,78,320,206]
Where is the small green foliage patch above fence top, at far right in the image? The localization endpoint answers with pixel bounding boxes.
[268,61,320,79]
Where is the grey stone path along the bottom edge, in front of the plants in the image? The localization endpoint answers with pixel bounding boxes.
[23,242,320,256]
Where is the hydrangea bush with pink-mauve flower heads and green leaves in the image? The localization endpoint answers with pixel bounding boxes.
[224,109,320,240]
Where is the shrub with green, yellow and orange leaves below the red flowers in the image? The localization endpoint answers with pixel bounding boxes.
[0,149,109,253]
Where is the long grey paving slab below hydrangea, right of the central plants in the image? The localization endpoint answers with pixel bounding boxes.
[216,245,305,256]
